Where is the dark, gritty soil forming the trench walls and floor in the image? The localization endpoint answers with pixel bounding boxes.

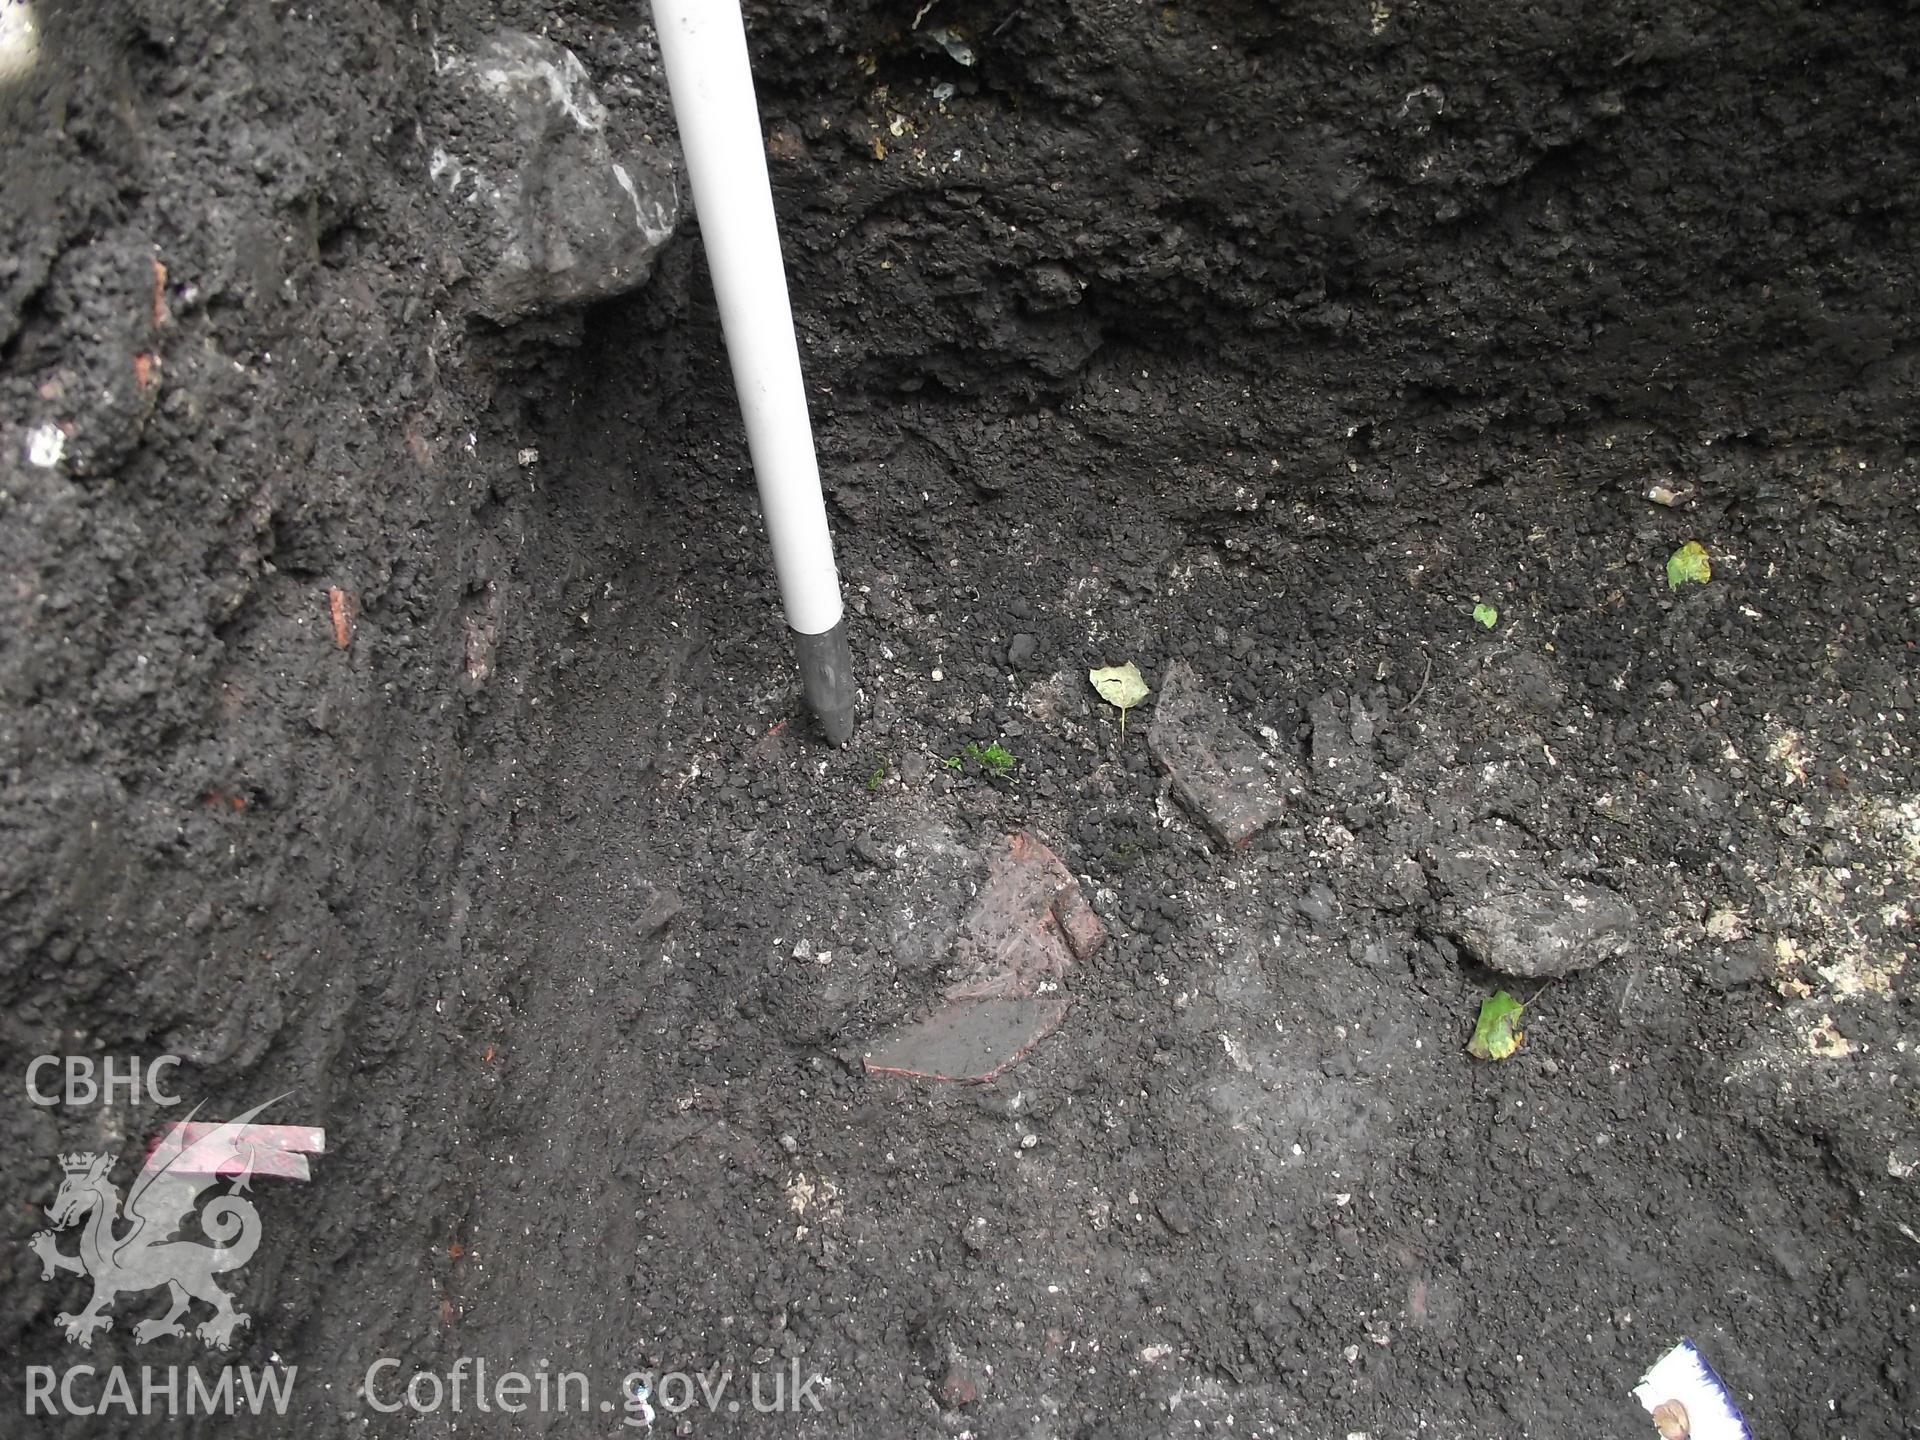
[0,0,1920,1440]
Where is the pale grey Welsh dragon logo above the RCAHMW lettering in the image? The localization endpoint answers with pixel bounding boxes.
[29,1096,284,1350]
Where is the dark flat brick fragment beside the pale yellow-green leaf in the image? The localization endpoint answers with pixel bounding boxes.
[1146,660,1284,849]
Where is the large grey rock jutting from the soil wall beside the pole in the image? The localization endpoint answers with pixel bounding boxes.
[428,31,680,323]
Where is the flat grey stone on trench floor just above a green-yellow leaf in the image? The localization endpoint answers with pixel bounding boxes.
[1428,829,1640,979]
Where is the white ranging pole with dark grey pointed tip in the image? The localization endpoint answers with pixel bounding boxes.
[653,0,854,745]
